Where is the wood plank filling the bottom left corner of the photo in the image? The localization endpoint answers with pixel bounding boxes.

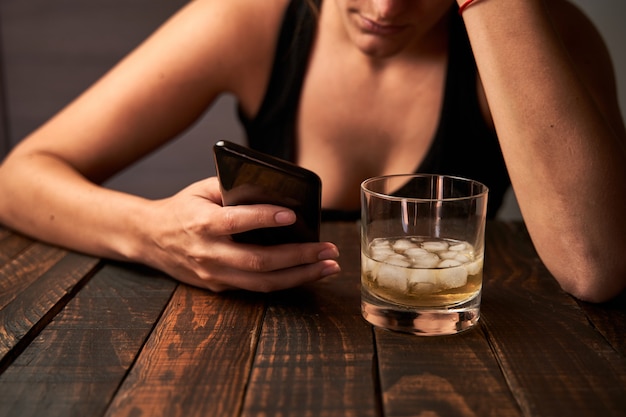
[0,264,177,417]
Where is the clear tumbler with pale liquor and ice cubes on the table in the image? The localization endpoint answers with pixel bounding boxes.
[361,174,489,335]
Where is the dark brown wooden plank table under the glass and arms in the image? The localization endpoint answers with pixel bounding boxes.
[0,222,626,417]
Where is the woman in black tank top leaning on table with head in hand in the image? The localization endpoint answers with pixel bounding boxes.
[0,0,626,302]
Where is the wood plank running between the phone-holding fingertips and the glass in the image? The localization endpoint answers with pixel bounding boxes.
[242,219,379,417]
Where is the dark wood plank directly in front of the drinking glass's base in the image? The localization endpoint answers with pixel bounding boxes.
[375,325,522,417]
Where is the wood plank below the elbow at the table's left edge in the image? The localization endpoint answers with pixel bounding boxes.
[0,244,98,360]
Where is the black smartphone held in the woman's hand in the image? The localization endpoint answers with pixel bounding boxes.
[213,140,322,245]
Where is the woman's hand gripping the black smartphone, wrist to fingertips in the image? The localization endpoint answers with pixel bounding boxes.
[138,178,339,292]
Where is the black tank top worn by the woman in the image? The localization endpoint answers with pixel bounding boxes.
[239,0,510,218]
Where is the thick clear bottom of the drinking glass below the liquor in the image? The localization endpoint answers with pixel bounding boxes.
[361,286,480,336]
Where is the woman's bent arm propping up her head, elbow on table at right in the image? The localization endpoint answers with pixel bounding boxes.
[459,0,626,302]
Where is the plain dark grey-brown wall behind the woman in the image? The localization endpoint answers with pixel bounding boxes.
[0,0,626,218]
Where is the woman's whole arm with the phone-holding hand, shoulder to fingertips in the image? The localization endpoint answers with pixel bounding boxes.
[0,0,337,291]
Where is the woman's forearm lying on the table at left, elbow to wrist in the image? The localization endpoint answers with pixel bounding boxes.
[0,150,148,260]
